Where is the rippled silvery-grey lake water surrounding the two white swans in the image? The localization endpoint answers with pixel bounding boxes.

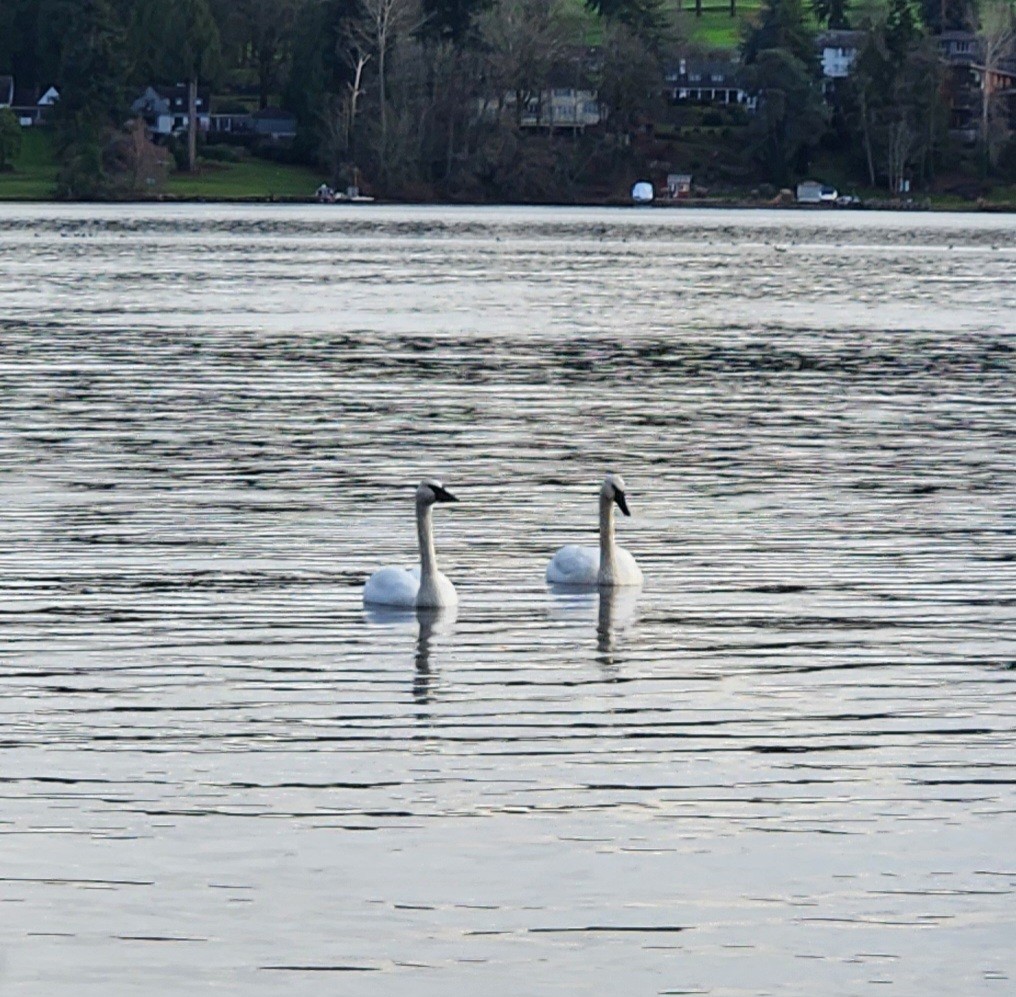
[0,205,1016,997]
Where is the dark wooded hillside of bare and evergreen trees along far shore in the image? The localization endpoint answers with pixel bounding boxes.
[0,0,1016,202]
